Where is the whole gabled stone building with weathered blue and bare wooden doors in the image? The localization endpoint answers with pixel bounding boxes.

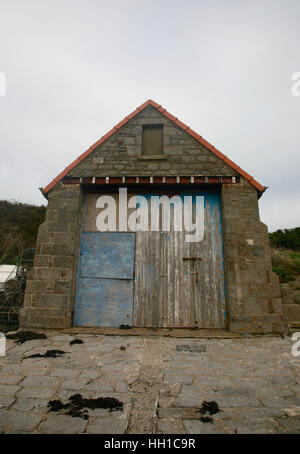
[20,100,285,333]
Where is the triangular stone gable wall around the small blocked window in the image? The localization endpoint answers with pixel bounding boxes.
[68,106,237,177]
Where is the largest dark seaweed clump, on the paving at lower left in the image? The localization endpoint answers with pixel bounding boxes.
[48,394,123,419]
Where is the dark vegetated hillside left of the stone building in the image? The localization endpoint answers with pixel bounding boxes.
[0,200,46,265]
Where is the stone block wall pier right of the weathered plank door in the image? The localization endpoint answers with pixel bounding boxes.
[222,181,285,333]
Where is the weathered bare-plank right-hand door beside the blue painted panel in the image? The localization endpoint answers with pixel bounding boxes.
[133,193,226,328]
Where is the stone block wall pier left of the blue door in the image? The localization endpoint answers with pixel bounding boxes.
[20,184,82,328]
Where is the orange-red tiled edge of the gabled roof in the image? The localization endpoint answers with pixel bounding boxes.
[42,99,266,195]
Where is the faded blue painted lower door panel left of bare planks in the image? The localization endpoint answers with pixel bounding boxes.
[75,232,135,327]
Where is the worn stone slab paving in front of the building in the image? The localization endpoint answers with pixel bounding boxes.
[0,329,300,434]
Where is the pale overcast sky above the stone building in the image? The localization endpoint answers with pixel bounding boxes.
[0,0,300,231]
